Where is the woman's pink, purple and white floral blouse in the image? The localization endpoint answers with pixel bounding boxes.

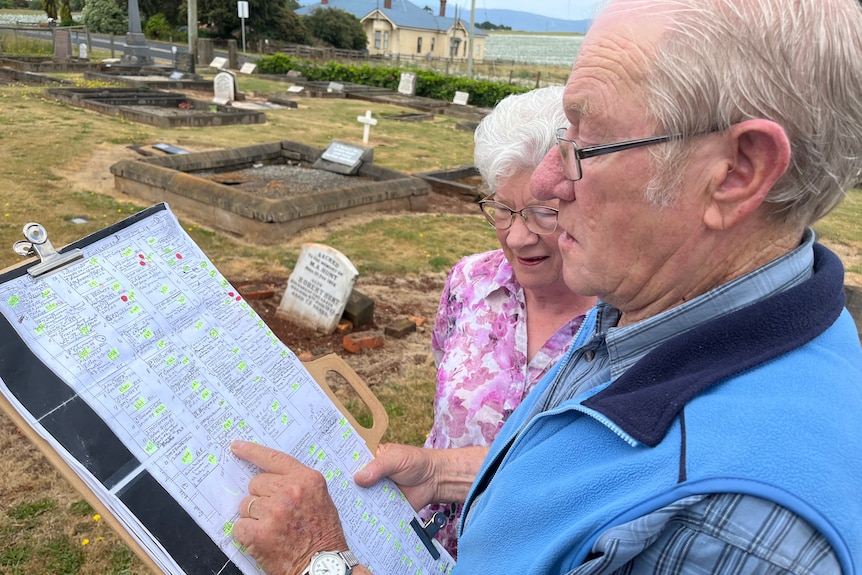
[422,250,584,557]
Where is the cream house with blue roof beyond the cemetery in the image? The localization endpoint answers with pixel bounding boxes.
[296,0,488,62]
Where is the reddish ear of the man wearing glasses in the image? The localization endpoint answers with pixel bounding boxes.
[704,119,790,230]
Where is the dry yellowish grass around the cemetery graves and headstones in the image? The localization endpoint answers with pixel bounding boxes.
[0,77,862,575]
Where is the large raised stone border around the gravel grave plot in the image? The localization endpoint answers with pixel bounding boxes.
[111,140,430,245]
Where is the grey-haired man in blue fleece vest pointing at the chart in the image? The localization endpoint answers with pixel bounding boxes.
[234,0,862,575]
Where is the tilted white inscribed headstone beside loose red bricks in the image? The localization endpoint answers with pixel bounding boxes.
[275,244,359,334]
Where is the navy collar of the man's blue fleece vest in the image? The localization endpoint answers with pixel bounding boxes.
[582,244,844,447]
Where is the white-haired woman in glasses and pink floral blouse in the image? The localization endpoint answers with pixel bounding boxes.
[423,87,595,556]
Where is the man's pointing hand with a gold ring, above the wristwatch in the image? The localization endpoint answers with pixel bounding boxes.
[231,441,347,575]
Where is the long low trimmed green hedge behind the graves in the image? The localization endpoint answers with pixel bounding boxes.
[257,54,529,108]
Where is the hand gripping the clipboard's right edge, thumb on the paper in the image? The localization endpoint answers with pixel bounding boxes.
[353,443,488,511]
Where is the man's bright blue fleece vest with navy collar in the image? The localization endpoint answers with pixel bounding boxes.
[454,245,862,575]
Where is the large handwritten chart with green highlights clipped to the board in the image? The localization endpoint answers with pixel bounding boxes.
[0,204,460,575]
